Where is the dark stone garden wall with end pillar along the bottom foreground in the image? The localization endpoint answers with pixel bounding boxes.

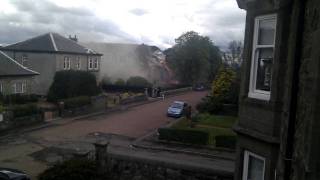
[95,143,233,180]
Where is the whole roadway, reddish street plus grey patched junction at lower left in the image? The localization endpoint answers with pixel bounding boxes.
[0,92,207,178]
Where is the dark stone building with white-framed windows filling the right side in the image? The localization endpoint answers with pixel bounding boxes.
[234,0,320,180]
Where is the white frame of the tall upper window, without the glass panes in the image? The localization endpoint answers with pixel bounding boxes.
[248,14,277,101]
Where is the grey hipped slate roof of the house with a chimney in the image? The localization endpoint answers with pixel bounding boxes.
[0,33,102,56]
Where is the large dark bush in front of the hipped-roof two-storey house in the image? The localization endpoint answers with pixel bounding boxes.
[48,70,99,102]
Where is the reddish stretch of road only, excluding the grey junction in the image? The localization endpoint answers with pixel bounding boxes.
[31,92,206,141]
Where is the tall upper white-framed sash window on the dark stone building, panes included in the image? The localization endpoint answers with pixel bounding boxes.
[248,14,277,100]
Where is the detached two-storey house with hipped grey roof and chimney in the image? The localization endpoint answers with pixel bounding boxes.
[0,33,102,95]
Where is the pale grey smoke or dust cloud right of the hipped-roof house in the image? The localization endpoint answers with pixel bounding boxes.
[80,42,168,84]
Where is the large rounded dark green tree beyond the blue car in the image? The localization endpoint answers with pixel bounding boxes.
[165,31,221,84]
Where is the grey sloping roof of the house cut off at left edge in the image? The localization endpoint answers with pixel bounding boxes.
[0,51,39,77]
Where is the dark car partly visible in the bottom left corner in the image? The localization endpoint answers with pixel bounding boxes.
[0,168,30,180]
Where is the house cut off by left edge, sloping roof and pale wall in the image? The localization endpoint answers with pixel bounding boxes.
[0,51,39,95]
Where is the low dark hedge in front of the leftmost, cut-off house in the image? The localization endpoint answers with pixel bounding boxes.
[10,104,40,118]
